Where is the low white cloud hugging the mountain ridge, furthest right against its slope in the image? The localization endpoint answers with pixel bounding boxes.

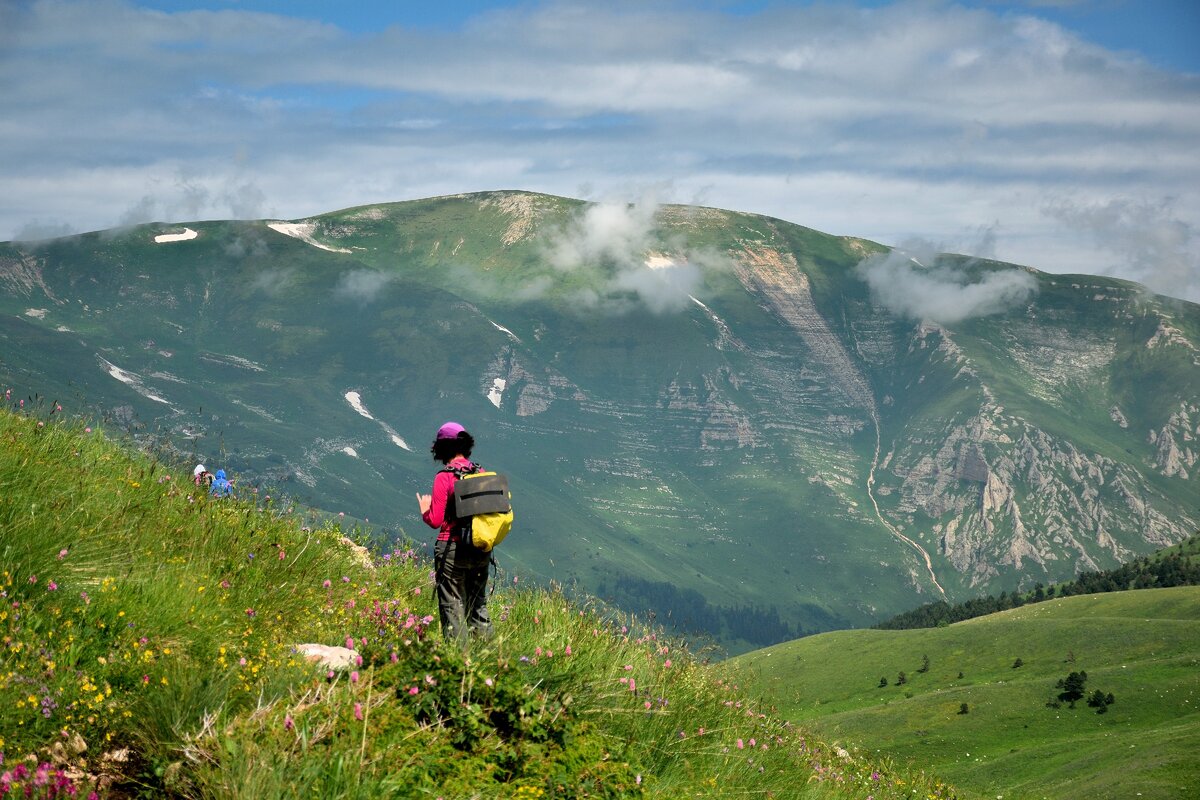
[856,242,1038,325]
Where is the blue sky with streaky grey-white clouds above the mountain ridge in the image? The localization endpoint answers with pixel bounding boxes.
[7,0,1200,301]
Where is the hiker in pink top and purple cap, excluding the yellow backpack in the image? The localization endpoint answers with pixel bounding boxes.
[416,422,492,640]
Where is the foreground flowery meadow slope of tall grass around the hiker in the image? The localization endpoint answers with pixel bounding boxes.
[0,408,954,799]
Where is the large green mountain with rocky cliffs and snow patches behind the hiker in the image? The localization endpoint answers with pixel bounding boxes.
[0,192,1200,651]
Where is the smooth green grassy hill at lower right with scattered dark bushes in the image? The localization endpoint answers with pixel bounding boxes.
[734,587,1200,799]
